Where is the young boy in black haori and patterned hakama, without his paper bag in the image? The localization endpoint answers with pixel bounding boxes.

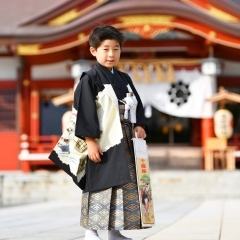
[49,25,147,240]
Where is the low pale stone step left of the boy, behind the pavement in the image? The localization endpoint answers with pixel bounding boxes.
[0,170,81,206]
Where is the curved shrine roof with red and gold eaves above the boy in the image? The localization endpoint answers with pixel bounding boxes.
[0,0,240,54]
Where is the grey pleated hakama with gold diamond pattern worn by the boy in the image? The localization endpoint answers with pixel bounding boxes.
[80,122,142,230]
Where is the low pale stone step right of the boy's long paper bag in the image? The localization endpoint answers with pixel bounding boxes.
[151,170,240,200]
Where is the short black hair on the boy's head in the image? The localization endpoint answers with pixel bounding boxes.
[89,25,125,49]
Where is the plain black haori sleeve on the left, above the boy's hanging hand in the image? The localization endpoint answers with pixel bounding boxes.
[74,74,100,138]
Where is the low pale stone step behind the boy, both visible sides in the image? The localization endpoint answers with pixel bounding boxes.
[0,169,240,206]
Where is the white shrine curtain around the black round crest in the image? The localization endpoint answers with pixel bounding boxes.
[127,69,216,118]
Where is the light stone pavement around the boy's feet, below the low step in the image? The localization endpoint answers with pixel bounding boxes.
[0,199,240,240]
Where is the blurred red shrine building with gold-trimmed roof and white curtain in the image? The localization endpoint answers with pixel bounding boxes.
[0,0,240,171]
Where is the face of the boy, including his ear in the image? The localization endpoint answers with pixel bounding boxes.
[90,39,121,70]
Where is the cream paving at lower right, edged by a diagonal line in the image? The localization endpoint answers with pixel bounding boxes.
[146,199,240,240]
